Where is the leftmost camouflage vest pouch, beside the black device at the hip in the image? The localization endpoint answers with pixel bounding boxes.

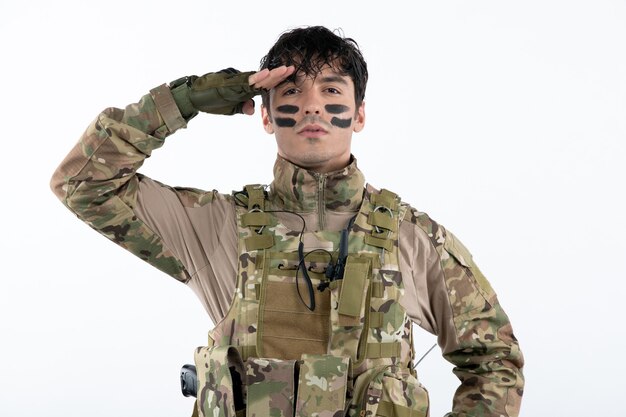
[194,346,246,417]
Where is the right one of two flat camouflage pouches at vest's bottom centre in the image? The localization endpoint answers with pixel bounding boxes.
[296,355,350,417]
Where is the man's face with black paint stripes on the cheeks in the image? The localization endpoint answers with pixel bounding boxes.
[261,67,365,172]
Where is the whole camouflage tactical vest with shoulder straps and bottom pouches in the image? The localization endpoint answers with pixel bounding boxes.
[194,186,428,417]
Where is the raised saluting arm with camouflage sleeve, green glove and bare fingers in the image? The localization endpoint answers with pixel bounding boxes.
[51,67,293,282]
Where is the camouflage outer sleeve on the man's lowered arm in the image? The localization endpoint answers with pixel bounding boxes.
[404,210,524,417]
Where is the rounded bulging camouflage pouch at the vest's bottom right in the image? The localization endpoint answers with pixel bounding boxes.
[349,367,429,417]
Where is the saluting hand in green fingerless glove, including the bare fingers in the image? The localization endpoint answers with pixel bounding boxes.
[170,66,295,115]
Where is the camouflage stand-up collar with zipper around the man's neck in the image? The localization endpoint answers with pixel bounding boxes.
[270,156,365,212]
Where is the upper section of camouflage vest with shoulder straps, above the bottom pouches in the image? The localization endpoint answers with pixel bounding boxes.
[218,185,411,373]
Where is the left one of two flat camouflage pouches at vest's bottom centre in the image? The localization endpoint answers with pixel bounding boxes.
[246,358,297,417]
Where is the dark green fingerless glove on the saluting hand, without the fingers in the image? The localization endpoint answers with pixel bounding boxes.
[170,68,261,115]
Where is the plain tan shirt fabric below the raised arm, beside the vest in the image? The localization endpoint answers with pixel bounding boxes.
[136,178,237,323]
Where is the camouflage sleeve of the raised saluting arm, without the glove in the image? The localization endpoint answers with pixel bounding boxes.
[50,85,192,282]
